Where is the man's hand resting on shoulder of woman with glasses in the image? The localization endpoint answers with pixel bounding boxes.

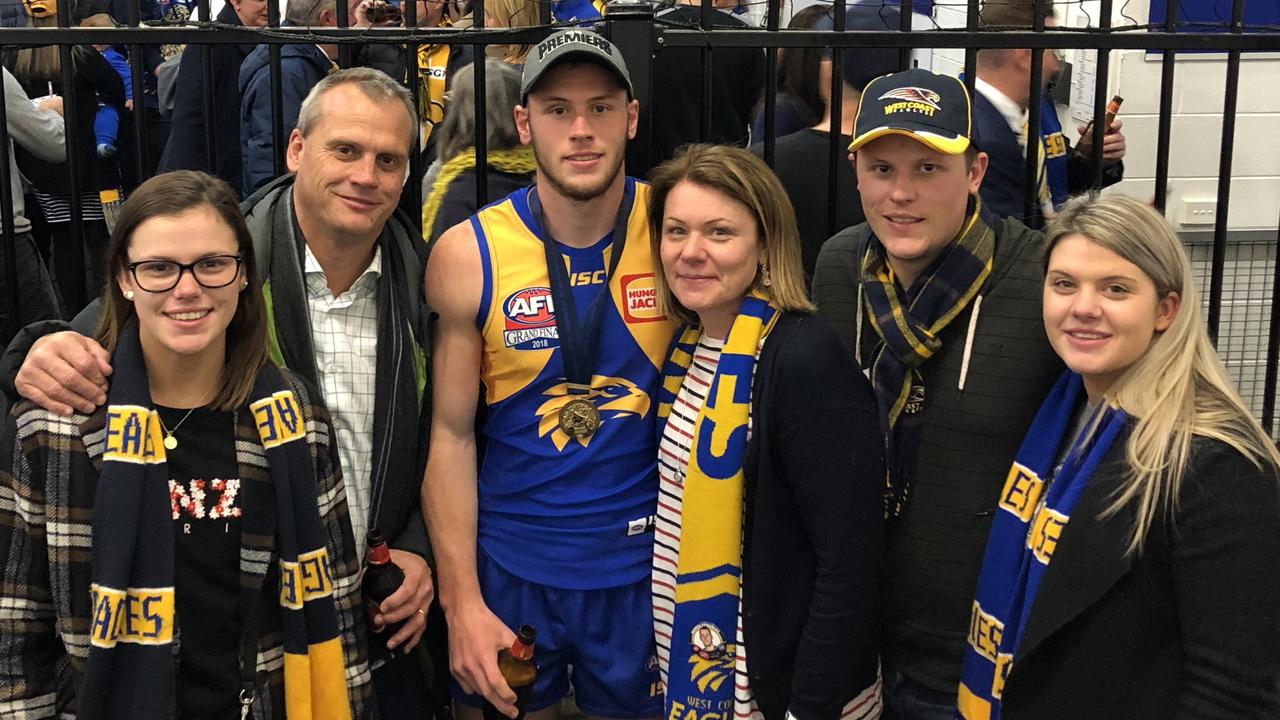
[14,331,111,416]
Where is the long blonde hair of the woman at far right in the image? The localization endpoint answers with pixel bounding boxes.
[1044,195,1280,552]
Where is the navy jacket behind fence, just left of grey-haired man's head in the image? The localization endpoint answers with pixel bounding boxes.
[239,35,333,196]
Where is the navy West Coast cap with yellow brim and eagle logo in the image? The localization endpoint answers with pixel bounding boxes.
[849,68,975,155]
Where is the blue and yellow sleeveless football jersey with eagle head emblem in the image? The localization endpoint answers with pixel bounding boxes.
[471,178,675,589]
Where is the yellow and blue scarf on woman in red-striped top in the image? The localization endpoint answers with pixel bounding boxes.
[658,293,781,717]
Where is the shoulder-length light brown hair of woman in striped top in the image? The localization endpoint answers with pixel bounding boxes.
[649,145,814,324]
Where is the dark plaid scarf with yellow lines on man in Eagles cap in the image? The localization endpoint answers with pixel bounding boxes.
[863,196,996,516]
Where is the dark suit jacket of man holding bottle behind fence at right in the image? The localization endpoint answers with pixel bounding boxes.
[973,91,1124,229]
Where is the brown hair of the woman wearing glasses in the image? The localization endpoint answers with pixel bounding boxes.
[97,170,266,410]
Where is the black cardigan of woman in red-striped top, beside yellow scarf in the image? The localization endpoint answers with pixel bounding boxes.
[742,313,884,720]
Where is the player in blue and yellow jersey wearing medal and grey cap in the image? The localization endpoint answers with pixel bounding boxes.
[422,29,673,719]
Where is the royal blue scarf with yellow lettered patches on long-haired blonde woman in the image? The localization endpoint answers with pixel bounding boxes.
[956,372,1128,720]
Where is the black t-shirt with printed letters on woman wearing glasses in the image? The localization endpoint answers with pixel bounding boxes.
[157,407,242,720]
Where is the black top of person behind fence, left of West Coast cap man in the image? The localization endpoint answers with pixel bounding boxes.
[751,128,867,278]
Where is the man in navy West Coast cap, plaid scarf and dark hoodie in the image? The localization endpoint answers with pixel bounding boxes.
[814,69,1062,720]
